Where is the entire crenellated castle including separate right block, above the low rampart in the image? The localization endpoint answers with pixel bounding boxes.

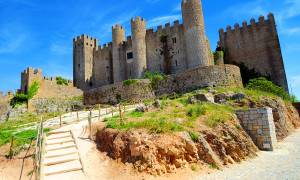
[73,0,288,92]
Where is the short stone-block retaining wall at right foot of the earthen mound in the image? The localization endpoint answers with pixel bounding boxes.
[236,107,277,151]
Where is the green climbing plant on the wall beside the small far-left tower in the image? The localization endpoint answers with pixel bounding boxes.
[10,81,40,107]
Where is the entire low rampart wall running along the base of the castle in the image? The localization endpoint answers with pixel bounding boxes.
[84,65,243,105]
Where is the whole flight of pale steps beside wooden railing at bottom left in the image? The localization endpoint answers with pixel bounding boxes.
[41,131,85,180]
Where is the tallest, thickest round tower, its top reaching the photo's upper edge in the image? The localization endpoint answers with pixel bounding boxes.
[181,0,212,68]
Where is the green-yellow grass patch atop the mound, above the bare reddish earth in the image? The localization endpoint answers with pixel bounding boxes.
[105,93,234,133]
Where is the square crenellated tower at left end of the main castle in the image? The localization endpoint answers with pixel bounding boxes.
[73,35,98,90]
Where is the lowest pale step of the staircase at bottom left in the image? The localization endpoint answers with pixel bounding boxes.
[44,160,82,176]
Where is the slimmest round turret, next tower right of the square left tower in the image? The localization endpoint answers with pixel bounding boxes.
[112,24,125,83]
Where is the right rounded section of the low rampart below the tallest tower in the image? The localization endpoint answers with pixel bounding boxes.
[156,65,243,96]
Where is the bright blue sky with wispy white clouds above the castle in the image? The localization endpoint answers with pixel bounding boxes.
[0,0,300,97]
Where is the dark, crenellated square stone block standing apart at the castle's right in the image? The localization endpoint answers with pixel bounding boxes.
[219,14,288,91]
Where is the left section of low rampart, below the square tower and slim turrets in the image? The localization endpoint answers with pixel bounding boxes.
[84,80,155,105]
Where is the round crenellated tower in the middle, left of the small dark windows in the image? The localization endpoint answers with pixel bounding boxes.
[131,17,147,78]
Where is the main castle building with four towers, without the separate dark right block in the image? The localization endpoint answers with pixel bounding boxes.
[73,0,213,90]
